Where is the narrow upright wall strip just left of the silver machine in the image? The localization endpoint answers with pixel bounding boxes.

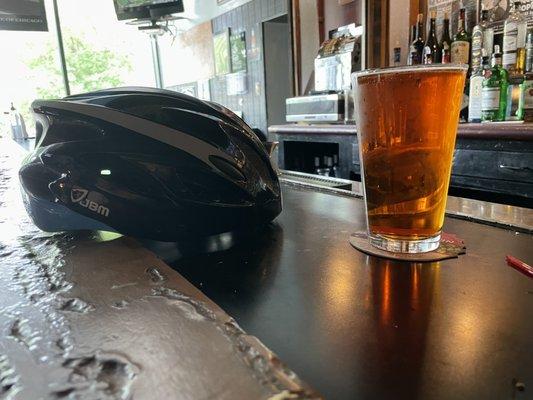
[299,0,320,94]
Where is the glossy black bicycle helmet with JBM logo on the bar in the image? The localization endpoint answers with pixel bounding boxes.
[19,88,281,241]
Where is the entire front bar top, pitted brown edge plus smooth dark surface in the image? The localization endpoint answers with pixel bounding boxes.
[0,141,533,400]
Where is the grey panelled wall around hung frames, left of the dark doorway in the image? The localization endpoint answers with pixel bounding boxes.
[210,0,289,134]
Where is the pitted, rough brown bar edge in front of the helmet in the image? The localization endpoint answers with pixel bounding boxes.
[0,141,319,400]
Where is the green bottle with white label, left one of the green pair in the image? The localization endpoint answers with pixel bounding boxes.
[481,45,509,122]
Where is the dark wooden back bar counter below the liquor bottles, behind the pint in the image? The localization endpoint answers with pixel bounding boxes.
[269,123,533,206]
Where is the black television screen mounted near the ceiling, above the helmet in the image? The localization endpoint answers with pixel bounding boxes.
[114,0,183,20]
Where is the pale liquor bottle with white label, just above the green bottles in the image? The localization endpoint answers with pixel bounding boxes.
[502,1,527,72]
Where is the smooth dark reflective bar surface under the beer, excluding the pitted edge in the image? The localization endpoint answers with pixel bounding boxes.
[173,180,533,399]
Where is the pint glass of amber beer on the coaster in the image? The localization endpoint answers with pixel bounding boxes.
[352,64,467,253]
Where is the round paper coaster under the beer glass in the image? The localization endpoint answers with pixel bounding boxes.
[350,232,466,262]
